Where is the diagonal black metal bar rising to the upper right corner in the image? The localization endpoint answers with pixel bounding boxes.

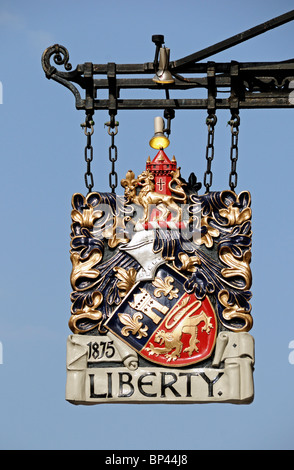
[171,10,294,72]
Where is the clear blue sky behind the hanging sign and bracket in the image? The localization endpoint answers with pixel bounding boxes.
[0,0,294,450]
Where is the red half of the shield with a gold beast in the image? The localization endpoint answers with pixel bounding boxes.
[140,294,217,367]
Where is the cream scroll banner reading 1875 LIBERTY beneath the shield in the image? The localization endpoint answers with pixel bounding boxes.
[66,331,254,405]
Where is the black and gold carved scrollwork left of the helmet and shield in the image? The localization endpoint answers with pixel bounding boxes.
[69,193,138,333]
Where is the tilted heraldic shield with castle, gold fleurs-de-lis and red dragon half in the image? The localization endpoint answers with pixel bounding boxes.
[105,264,217,367]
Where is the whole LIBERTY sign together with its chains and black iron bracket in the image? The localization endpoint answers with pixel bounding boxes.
[41,10,294,405]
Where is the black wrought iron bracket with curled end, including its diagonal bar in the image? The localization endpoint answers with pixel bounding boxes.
[42,10,294,113]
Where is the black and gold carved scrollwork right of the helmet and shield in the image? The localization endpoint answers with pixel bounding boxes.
[154,191,253,331]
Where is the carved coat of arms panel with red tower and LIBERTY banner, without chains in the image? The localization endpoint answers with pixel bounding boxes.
[66,149,254,404]
